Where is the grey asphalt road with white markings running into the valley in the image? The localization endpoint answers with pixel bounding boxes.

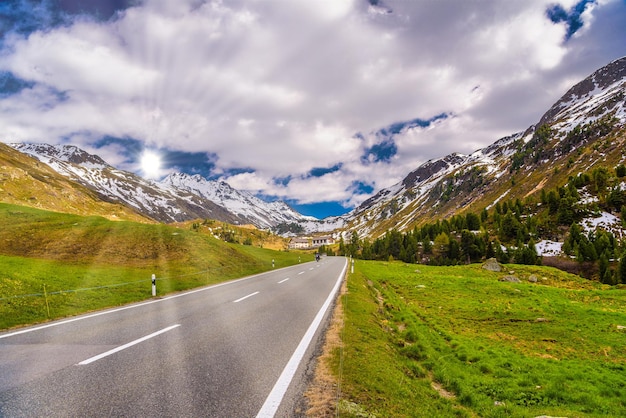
[0,257,347,417]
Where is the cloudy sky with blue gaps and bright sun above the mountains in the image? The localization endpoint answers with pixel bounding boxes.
[0,0,626,217]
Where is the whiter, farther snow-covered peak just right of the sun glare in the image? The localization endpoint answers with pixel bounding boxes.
[160,173,315,228]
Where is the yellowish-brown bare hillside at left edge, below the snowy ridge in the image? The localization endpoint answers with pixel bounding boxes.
[0,143,151,222]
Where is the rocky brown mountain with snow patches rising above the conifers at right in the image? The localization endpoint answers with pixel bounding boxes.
[330,57,626,238]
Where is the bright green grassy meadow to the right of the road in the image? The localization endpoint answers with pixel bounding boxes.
[331,260,626,417]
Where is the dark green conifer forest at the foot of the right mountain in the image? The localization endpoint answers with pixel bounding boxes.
[334,165,626,284]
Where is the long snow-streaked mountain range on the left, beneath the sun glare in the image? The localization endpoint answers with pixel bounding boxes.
[11,143,313,229]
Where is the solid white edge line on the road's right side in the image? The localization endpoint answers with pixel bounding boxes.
[256,259,348,418]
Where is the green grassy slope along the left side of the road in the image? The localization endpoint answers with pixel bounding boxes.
[0,204,306,329]
